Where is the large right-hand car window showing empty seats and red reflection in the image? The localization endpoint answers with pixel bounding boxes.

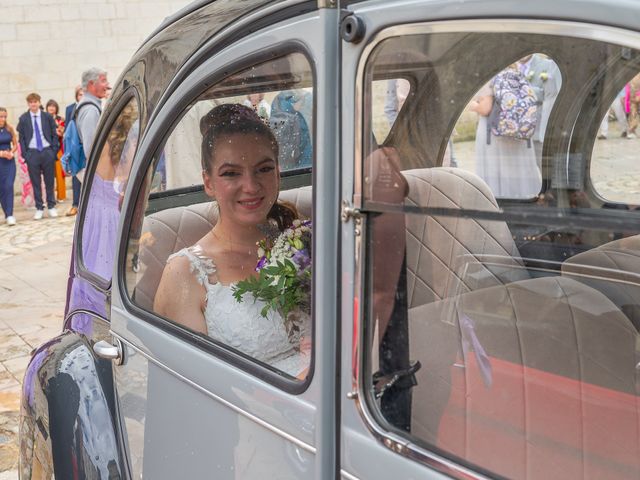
[359,27,640,479]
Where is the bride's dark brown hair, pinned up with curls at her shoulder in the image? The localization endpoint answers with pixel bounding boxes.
[200,103,299,230]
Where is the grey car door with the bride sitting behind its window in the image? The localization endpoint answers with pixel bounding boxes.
[111,9,338,479]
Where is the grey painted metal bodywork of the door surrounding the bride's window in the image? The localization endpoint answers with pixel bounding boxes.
[111,11,337,478]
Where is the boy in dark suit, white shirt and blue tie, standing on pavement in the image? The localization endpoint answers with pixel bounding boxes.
[17,93,60,220]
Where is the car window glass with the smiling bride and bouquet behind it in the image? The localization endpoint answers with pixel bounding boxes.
[126,53,313,379]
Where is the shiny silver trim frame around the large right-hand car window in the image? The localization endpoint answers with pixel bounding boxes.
[350,17,640,478]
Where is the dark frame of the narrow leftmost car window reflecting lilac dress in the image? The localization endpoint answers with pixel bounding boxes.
[73,86,143,293]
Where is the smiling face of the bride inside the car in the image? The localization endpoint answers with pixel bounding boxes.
[203,133,280,229]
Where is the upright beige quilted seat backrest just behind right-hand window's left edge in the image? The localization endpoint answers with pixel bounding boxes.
[403,167,529,307]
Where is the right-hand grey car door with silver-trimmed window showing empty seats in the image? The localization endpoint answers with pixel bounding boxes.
[340,1,640,479]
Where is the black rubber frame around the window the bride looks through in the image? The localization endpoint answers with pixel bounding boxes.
[116,40,318,395]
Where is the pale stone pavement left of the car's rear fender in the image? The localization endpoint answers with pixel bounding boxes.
[0,197,75,480]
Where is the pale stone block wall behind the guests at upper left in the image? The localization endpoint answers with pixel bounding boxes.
[0,0,190,125]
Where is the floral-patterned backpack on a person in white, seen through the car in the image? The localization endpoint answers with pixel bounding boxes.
[487,69,538,145]
